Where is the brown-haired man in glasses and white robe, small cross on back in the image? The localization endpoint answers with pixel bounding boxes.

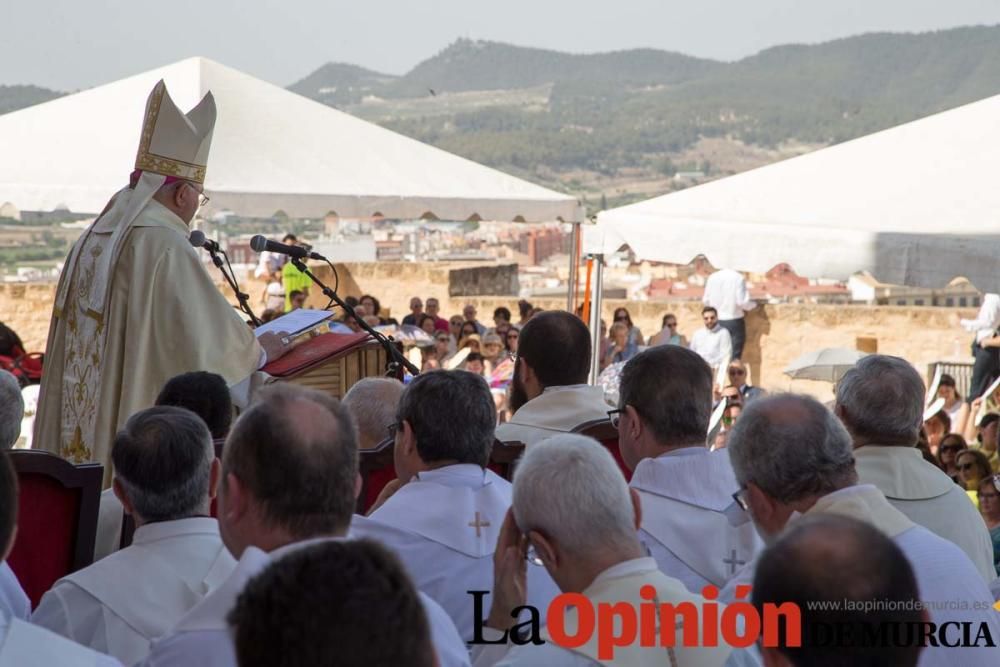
[618,345,763,593]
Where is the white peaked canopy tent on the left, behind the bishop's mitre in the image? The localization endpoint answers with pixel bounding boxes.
[0,58,583,222]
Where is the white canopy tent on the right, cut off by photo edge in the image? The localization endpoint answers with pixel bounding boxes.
[583,96,1000,292]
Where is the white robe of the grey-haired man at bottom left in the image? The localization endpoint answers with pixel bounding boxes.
[32,517,236,665]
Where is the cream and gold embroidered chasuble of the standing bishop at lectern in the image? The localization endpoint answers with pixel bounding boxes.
[34,190,261,486]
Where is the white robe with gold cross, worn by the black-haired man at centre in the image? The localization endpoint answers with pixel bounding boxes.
[350,464,558,641]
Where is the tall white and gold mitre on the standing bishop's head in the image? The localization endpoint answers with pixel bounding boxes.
[135,79,215,183]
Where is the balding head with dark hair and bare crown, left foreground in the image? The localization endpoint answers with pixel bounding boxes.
[222,383,358,539]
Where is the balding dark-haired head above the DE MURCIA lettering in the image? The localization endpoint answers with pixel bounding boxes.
[753,514,925,667]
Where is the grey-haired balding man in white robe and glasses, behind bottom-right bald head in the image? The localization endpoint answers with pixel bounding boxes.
[720,394,1000,667]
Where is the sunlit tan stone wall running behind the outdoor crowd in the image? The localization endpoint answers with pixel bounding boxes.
[0,263,975,400]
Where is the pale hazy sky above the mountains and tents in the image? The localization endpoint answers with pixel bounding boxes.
[7,0,1000,90]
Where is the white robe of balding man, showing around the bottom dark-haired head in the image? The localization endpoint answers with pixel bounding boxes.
[139,538,469,667]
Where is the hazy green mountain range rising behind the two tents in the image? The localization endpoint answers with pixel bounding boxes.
[293,26,1000,180]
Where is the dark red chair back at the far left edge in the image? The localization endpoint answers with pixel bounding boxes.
[7,474,81,608]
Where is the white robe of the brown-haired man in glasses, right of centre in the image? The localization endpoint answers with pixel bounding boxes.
[630,447,763,593]
